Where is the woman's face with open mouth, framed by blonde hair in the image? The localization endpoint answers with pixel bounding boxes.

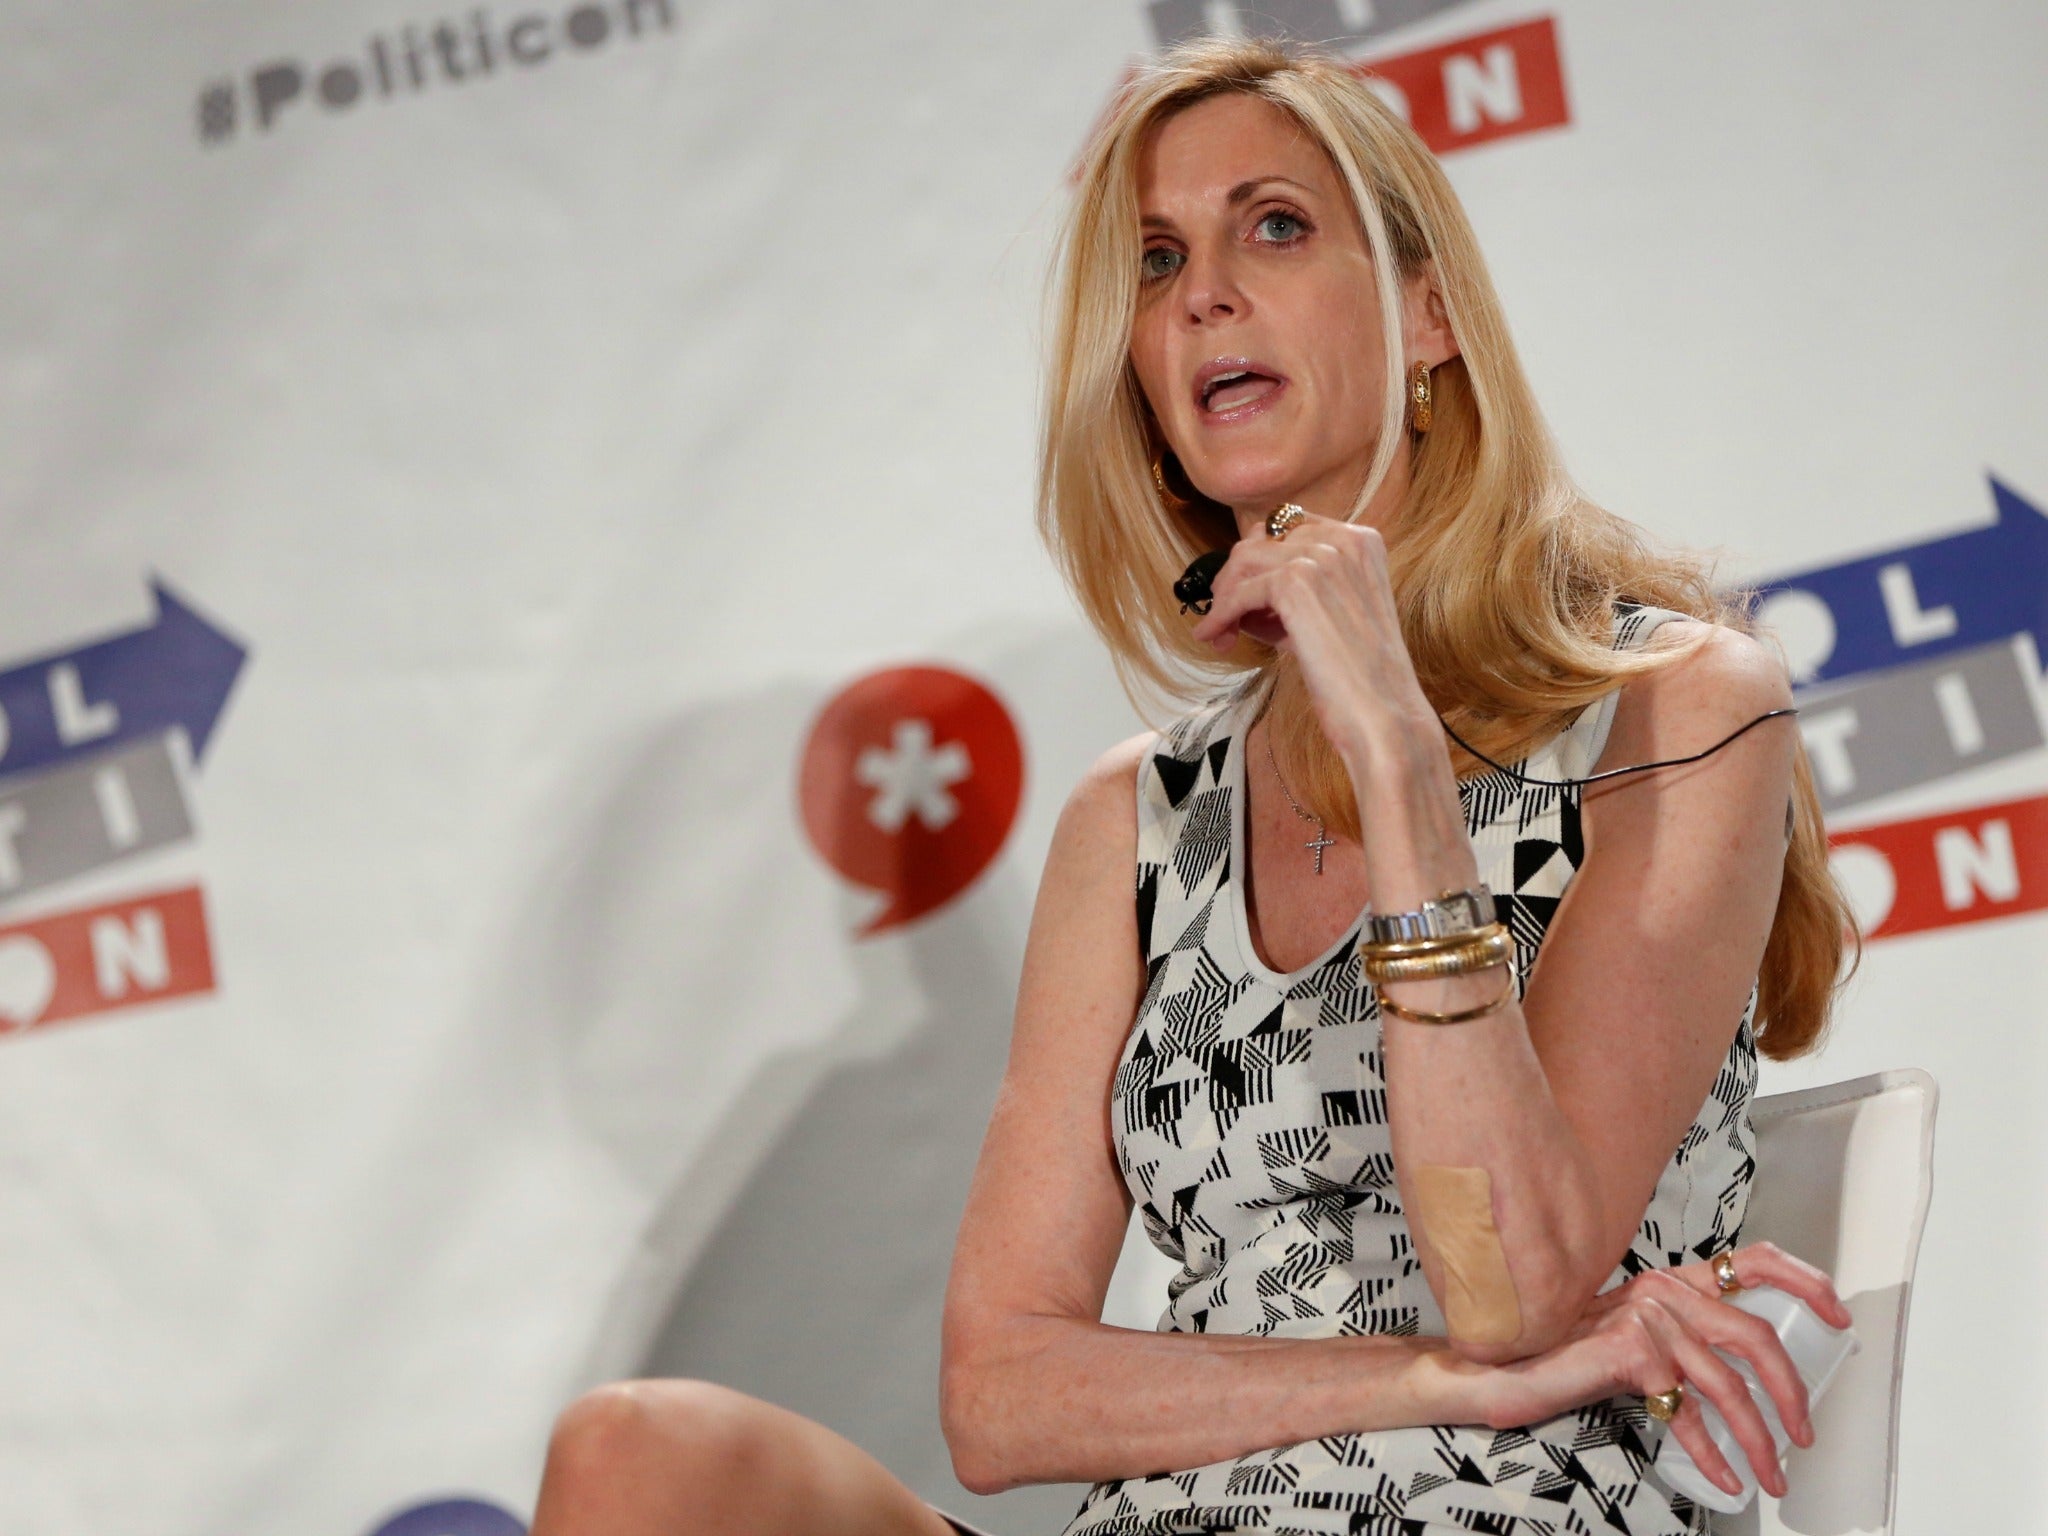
[1130,92,1456,530]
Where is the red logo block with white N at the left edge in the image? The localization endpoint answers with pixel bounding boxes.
[0,885,213,1034]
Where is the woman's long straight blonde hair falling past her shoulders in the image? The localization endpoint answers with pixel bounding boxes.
[1038,39,1860,1059]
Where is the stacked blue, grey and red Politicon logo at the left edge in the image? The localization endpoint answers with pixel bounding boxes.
[0,582,248,1034]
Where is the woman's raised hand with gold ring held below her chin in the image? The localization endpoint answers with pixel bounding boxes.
[1190,514,1442,760]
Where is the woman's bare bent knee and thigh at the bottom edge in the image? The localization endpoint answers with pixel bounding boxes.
[532,1380,954,1536]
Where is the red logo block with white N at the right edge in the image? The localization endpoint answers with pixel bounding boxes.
[1829,795,2048,938]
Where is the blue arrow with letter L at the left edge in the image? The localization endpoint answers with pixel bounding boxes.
[0,578,248,774]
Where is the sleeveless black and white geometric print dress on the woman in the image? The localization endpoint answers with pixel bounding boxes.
[1063,606,1757,1536]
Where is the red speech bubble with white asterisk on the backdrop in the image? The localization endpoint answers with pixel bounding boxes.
[797,668,1024,938]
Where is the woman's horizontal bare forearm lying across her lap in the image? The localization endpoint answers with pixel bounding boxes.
[940,1317,1489,1493]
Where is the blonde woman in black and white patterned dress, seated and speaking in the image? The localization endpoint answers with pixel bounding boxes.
[535,41,1849,1536]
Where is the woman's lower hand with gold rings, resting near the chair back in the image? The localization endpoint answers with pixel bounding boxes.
[1487,1243,1851,1497]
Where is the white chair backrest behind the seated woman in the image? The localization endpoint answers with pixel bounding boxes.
[1714,1067,1935,1536]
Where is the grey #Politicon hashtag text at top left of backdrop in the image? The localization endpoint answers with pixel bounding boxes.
[199,0,676,145]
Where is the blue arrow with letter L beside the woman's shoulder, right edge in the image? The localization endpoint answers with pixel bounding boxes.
[1757,475,2048,682]
